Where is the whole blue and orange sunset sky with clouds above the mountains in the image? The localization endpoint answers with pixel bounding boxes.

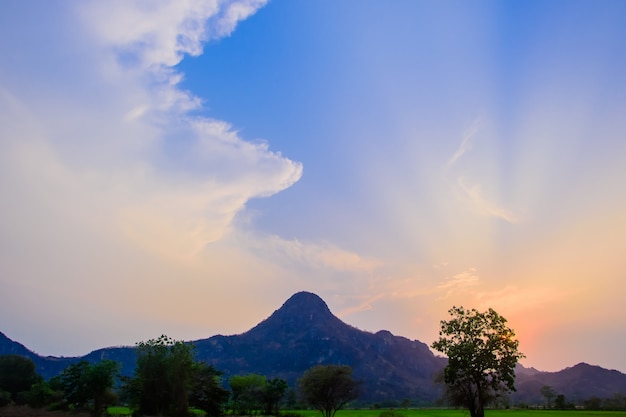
[0,0,626,372]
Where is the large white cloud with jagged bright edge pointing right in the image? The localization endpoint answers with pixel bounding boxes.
[3,1,302,257]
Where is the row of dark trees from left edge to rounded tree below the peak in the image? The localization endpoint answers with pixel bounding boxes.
[0,336,359,417]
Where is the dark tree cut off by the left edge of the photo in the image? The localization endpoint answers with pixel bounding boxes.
[0,355,42,401]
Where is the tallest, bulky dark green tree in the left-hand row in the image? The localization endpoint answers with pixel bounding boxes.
[125,335,195,416]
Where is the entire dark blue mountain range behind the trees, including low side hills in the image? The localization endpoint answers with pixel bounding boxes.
[0,292,626,405]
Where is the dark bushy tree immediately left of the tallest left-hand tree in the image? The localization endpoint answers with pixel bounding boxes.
[55,359,120,416]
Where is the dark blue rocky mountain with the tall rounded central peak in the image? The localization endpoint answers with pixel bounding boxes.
[194,292,445,403]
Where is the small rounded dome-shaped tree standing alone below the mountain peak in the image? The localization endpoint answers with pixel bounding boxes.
[299,365,361,417]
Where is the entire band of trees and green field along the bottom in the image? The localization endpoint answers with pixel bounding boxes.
[0,307,626,417]
